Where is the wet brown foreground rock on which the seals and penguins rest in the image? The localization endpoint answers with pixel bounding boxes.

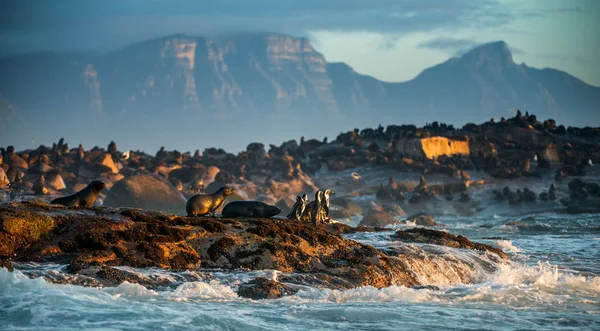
[0,202,503,292]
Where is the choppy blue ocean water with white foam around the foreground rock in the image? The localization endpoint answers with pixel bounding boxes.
[0,213,600,330]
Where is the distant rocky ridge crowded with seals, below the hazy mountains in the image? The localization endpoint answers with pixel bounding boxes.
[0,111,600,220]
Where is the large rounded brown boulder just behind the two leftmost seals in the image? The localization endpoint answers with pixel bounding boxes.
[104,175,186,215]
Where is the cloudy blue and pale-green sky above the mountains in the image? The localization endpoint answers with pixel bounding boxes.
[0,0,600,86]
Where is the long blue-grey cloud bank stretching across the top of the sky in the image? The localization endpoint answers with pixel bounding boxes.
[0,0,513,53]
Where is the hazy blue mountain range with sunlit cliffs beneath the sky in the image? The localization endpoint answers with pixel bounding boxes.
[0,33,600,151]
